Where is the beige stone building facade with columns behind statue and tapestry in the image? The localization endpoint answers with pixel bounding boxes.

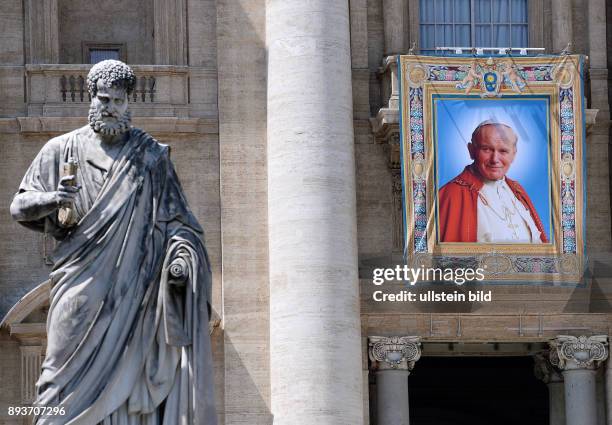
[0,0,612,425]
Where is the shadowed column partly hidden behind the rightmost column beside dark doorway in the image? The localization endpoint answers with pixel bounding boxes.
[534,353,565,425]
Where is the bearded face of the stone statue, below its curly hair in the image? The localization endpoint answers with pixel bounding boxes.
[89,80,131,136]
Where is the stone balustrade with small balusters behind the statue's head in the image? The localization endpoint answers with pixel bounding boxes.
[26,64,189,117]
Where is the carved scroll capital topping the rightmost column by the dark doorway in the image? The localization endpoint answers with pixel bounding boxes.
[550,335,608,371]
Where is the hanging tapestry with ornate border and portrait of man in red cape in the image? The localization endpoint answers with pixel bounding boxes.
[398,55,586,285]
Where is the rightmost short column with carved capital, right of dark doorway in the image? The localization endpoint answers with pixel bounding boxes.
[551,335,608,425]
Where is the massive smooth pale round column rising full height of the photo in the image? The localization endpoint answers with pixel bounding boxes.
[268,0,363,425]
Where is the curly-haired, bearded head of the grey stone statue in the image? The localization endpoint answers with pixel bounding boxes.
[87,60,136,136]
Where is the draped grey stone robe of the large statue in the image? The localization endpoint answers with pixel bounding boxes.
[20,127,216,425]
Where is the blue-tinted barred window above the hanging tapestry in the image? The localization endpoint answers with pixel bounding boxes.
[419,0,529,54]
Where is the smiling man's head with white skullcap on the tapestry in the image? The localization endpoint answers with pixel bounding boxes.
[468,125,516,180]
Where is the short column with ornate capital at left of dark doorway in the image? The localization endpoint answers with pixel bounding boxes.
[369,336,421,425]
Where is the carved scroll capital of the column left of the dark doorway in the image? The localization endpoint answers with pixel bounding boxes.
[368,336,421,371]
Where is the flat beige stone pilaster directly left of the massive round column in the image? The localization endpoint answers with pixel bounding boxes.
[216,0,273,425]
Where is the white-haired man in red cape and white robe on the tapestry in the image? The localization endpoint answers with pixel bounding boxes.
[438,119,548,244]
